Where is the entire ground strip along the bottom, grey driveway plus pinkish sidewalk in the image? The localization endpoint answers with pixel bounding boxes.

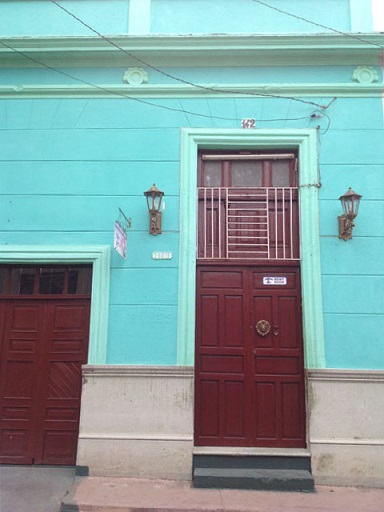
[0,466,384,512]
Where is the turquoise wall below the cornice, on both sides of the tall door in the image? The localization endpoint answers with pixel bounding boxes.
[0,92,384,369]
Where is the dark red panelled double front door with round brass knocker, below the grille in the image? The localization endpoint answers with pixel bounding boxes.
[195,265,305,447]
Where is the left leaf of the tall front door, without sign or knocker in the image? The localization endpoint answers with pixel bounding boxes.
[196,269,245,445]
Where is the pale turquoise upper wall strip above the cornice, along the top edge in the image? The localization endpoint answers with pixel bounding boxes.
[0,0,354,36]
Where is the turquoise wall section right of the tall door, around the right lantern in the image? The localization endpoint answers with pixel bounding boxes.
[320,99,384,369]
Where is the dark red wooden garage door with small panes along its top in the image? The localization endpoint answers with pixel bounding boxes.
[0,266,92,465]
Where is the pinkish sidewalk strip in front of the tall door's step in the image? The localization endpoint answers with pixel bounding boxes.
[61,477,384,512]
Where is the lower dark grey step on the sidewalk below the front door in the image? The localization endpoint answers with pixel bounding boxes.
[193,467,315,492]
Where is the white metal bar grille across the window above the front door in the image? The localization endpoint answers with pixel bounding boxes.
[197,187,299,260]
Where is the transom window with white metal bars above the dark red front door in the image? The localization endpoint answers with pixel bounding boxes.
[197,151,300,260]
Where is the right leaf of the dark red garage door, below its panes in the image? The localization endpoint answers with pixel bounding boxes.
[35,300,89,464]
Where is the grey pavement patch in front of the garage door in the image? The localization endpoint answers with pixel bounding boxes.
[0,466,75,512]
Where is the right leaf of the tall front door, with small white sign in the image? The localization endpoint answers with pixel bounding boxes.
[251,267,305,447]
